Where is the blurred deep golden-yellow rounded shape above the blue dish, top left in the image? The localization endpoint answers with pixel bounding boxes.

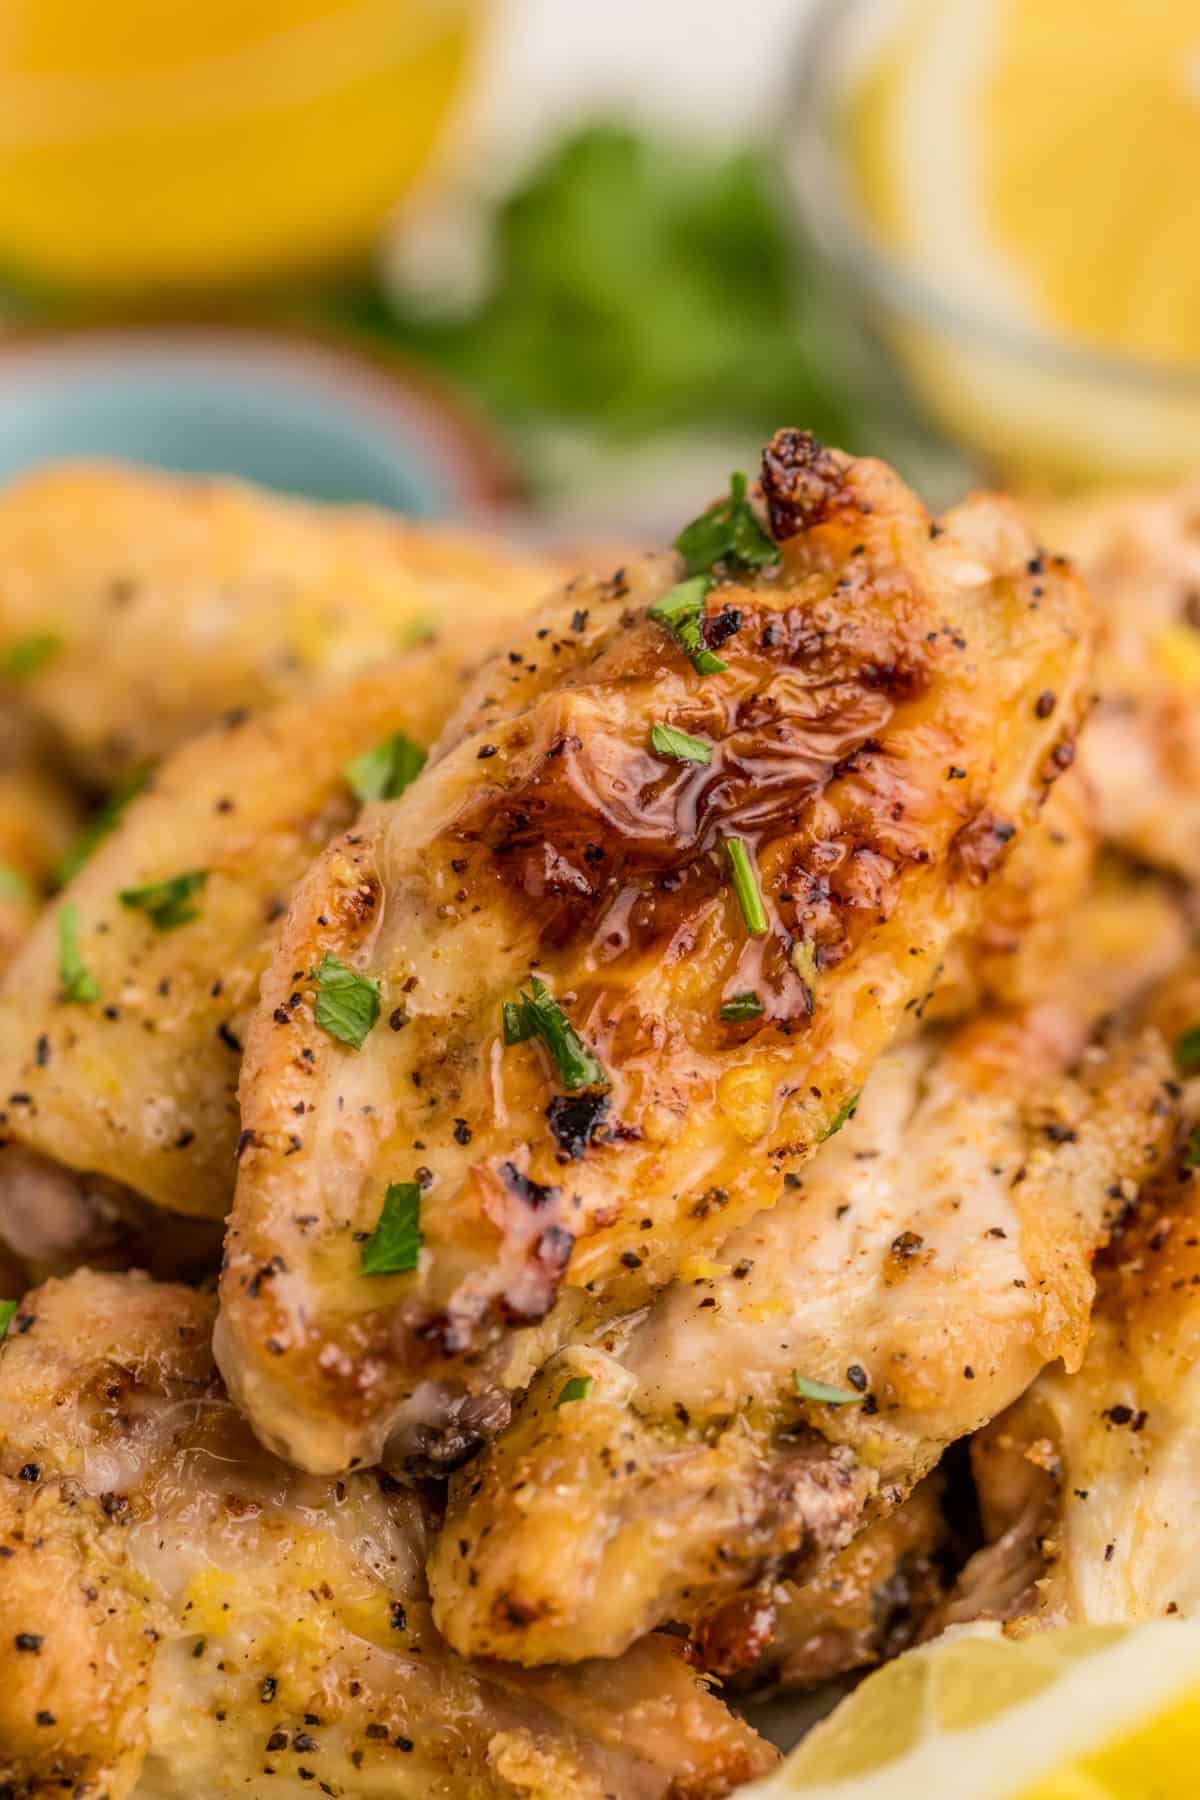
[0,0,484,290]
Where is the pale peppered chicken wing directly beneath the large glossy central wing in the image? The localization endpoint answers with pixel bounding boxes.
[430,1006,1173,1663]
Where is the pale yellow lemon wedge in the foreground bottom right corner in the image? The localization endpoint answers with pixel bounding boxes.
[743,1620,1200,1800]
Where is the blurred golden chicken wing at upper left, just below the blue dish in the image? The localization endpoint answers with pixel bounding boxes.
[0,464,561,787]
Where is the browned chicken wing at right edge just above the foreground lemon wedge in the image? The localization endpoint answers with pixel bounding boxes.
[950,963,1200,1624]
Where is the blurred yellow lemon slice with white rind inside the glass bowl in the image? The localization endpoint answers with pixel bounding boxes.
[856,0,1200,364]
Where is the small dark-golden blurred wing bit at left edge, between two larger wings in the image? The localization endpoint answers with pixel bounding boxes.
[0,713,79,972]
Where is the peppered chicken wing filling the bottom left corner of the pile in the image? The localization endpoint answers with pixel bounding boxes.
[0,1271,774,1800]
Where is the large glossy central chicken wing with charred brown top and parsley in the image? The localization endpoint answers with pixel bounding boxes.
[216,432,1088,1471]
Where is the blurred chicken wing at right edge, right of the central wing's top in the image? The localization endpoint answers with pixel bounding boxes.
[1036,477,1200,882]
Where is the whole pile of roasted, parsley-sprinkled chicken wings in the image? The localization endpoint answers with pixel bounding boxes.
[0,430,1200,1800]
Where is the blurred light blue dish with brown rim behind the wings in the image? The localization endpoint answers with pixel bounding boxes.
[0,326,515,517]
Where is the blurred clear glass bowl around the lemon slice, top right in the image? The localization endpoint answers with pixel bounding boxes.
[783,0,1200,486]
